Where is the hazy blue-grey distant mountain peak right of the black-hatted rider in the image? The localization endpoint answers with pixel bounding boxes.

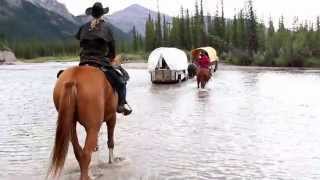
[106,4,172,36]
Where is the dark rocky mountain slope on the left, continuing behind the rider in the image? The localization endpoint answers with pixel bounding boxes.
[0,0,130,41]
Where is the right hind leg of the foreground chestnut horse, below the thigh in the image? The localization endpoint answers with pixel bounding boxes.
[80,129,99,180]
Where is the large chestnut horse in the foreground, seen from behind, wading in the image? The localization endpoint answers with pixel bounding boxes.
[50,57,119,180]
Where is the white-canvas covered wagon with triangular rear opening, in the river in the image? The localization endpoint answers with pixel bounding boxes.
[148,47,188,83]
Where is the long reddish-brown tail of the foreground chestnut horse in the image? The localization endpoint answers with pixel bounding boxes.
[50,81,77,176]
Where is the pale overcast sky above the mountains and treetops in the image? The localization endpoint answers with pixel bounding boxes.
[58,0,320,21]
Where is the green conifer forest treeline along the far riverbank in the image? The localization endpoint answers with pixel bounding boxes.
[0,0,320,67]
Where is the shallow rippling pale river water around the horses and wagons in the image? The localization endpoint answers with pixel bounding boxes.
[0,63,320,180]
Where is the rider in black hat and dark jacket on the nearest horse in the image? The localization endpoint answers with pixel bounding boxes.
[76,3,132,115]
